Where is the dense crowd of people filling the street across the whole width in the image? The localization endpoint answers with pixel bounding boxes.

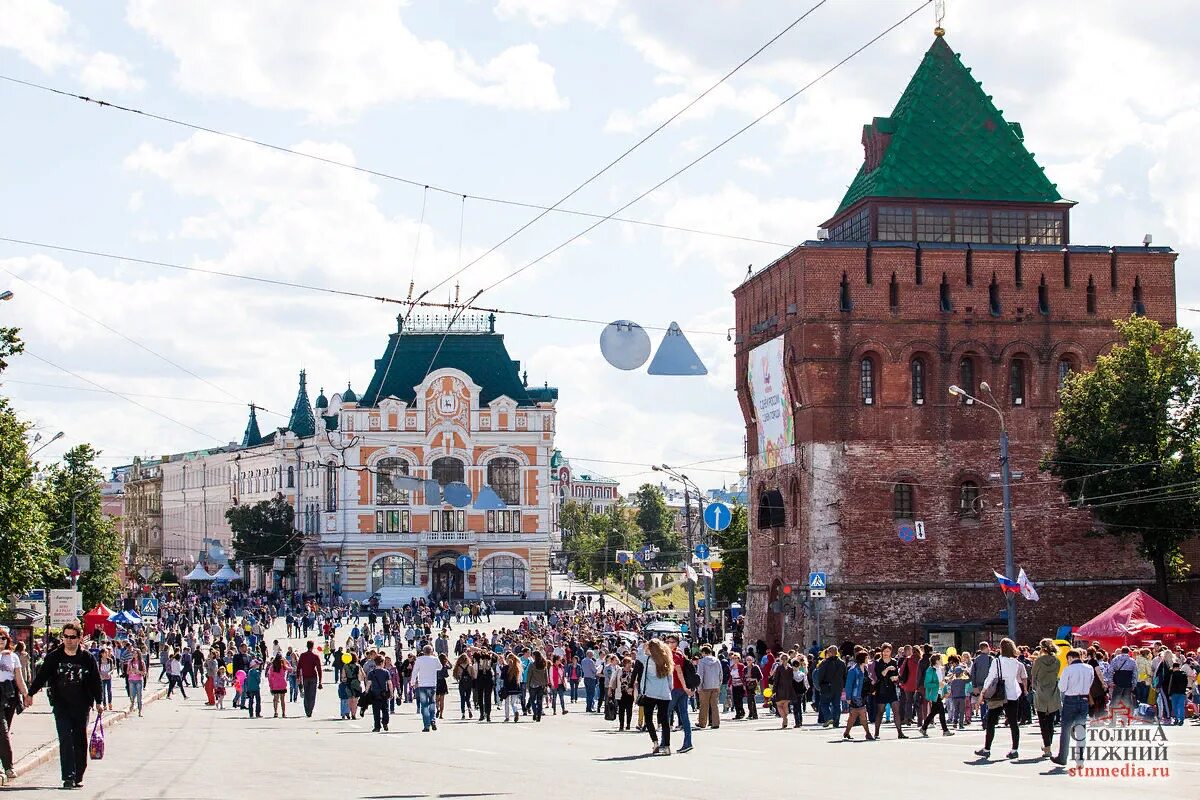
[0,594,1200,787]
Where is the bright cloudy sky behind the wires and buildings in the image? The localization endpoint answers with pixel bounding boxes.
[0,0,1200,488]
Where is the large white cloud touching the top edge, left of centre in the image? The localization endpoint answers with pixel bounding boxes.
[128,0,566,121]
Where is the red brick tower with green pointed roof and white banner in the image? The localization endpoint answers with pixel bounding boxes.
[734,36,1176,649]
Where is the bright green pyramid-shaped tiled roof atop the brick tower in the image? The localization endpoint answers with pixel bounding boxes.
[838,36,1062,213]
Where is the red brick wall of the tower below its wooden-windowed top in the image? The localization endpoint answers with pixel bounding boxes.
[734,242,1180,643]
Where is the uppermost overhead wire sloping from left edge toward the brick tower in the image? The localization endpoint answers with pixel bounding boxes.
[0,74,794,247]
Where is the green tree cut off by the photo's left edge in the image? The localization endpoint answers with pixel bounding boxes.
[0,398,62,606]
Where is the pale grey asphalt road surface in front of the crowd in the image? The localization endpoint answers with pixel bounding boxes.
[7,616,1200,800]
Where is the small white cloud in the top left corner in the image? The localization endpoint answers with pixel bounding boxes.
[0,0,145,91]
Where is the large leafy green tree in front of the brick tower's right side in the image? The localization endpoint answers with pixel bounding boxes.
[1043,315,1200,602]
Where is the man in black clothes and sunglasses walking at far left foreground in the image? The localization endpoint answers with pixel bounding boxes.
[29,622,104,789]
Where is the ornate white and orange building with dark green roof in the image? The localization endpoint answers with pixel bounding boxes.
[227,318,558,606]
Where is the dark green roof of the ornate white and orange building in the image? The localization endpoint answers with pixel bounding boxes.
[359,333,558,407]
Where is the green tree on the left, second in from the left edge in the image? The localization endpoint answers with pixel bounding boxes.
[44,444,121,608]
